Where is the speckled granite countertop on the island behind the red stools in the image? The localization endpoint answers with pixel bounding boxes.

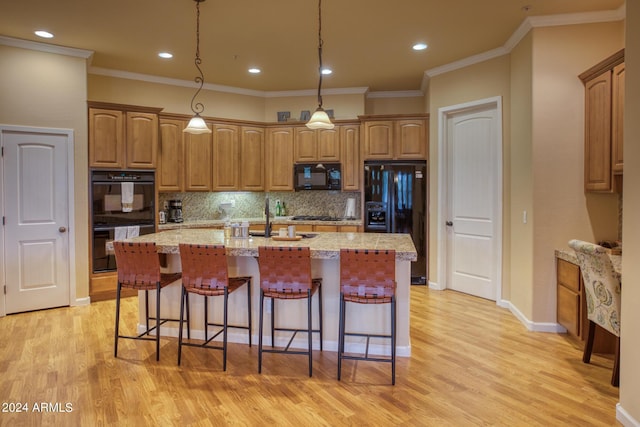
[121,229,417,261]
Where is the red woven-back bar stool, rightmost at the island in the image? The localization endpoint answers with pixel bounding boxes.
[338,249,396,385]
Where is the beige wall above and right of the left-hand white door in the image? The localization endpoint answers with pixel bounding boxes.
[0,45,89,298]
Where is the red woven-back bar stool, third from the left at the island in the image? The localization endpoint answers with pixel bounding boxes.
[258,246,322,376]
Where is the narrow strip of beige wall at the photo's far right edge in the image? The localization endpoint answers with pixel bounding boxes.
[620,1,640,423]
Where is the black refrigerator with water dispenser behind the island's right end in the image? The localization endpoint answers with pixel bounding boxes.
[364,161,427,285]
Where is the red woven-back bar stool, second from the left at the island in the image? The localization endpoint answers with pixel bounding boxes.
[178,243,251,371]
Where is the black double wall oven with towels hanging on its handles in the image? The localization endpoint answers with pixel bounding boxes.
[90,170,156,273]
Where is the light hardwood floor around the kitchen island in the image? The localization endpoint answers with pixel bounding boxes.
[0,287,618,426]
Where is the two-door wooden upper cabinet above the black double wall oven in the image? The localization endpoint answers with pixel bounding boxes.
[89,103,161,169]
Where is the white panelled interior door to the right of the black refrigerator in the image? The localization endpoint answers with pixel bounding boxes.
[441,99,502,301]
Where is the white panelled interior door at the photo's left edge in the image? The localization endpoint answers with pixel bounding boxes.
[2,130,70,314]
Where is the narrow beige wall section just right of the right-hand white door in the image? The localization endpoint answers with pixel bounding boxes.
[504,33,536,319]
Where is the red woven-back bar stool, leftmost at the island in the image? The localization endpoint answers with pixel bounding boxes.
[113,241,184,360]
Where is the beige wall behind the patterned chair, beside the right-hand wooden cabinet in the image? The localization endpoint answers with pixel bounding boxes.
[532,22,624,322]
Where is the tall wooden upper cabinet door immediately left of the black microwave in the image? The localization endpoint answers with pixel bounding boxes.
[266,127,293,191]
